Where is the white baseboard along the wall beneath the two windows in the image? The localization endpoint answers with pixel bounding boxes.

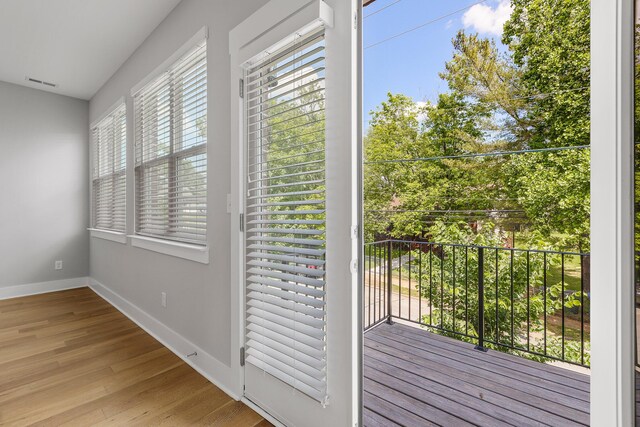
[89,278,242,400]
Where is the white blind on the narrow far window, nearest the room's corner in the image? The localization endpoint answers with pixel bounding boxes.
[91,104,127,233]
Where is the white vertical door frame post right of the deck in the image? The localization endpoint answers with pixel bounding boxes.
[590,0,635,426]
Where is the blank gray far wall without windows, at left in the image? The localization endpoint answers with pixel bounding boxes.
[0,82,89,287]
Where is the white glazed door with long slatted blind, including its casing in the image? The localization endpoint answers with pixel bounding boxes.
[230,0,359,426]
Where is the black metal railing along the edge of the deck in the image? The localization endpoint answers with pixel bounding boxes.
[364,240,590,366]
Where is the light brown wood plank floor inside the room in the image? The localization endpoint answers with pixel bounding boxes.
[0,288,270,427]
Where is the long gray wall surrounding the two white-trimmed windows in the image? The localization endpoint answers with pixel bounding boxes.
[90,0,266,365]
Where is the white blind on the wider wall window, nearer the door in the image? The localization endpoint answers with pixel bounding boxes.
[134,41,207,245]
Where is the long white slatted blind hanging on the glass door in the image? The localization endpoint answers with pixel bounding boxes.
[244,28,327,402]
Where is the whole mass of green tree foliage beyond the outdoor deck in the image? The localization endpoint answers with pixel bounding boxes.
[364,0,592,363]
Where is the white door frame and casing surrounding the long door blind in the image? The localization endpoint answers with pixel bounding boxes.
[229,0,360,426]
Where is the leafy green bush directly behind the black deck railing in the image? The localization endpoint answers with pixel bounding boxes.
[412,222,588,363]
